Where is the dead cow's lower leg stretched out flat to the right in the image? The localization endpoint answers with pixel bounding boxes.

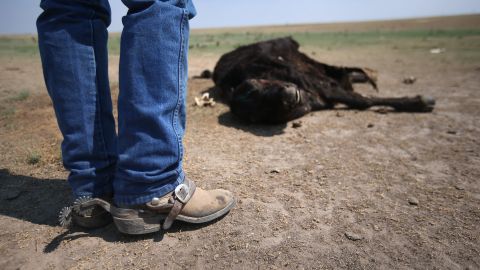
[324,88,435,112]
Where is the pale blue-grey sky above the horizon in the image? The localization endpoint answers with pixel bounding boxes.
[0,0,480,34]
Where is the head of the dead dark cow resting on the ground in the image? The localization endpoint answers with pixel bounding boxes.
[230,79,311,124]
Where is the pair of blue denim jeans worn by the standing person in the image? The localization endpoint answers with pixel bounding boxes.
[37,0,195,205]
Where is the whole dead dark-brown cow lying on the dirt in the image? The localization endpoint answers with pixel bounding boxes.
[213,37,435,123]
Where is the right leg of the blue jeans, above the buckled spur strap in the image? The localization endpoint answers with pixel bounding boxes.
[114,0,195,205]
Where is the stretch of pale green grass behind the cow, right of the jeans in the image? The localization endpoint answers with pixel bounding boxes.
[190,29,480,54]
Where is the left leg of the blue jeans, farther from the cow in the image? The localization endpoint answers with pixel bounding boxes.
[37,0,117,197]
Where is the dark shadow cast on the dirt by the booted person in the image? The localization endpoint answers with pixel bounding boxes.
[0,169,221,253]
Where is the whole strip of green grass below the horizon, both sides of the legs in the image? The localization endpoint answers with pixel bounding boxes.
[0,21,480,57]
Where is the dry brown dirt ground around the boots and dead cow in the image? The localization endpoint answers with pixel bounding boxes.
[0,15,480,269]
